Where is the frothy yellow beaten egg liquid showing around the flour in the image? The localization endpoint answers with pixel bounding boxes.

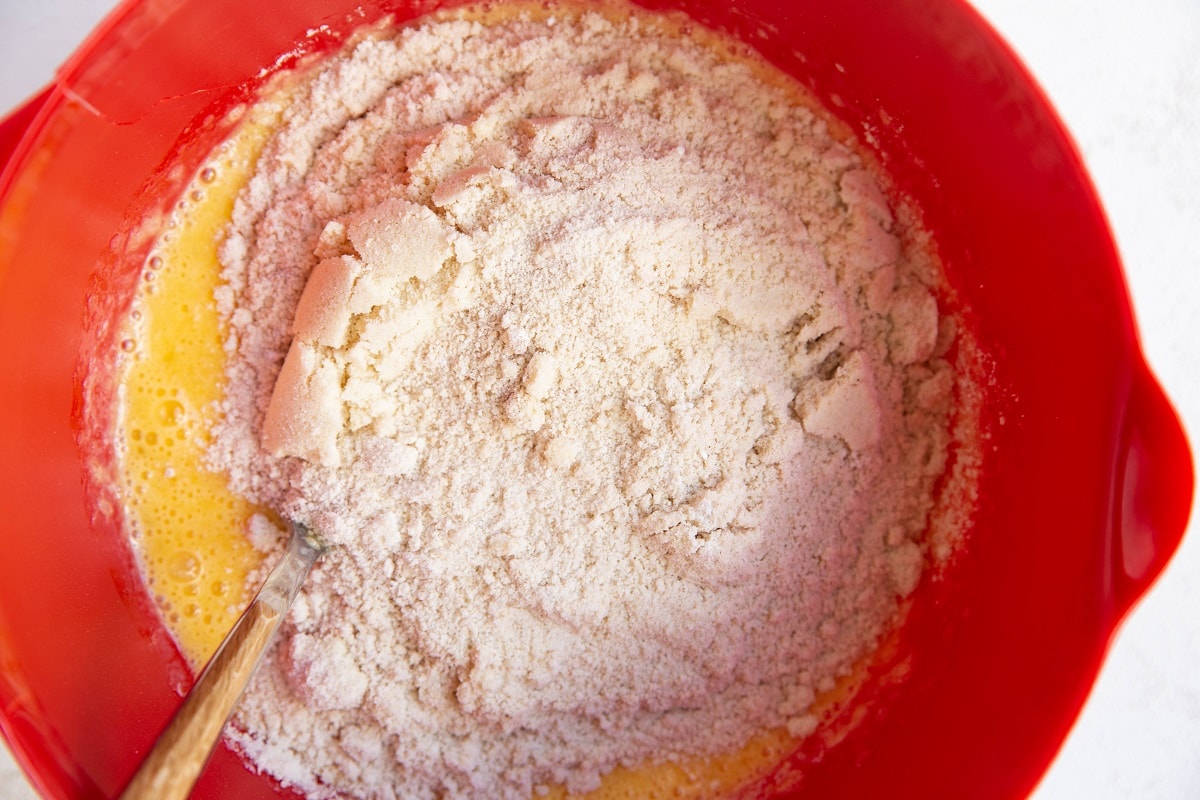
[119,31,816,800]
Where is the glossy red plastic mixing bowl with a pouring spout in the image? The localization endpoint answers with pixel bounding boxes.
[0,0,1193,799]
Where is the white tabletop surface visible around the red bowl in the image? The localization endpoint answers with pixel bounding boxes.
[0,0,1200,800]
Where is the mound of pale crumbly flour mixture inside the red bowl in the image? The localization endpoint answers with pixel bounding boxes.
[211,7,956,798]
